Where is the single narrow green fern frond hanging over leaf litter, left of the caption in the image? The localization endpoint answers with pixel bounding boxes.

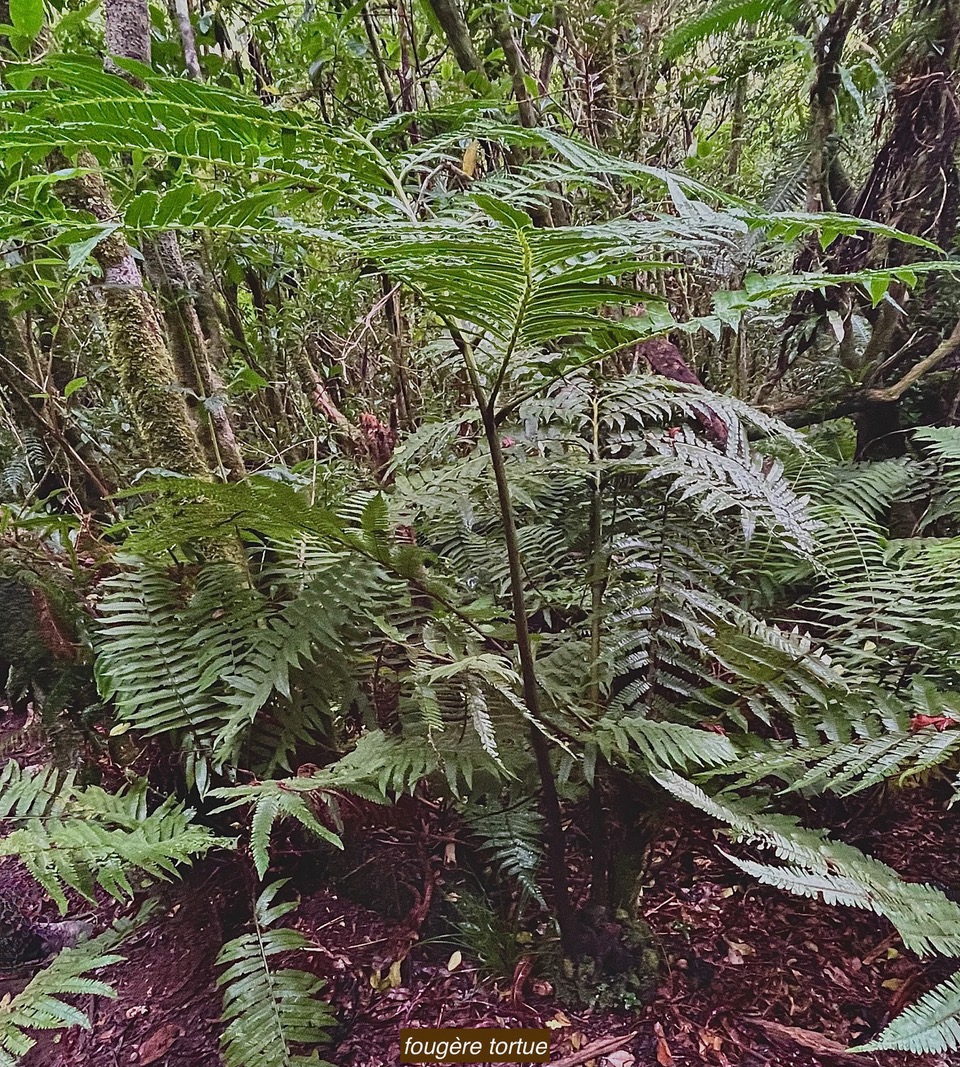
[217,878,336,1067]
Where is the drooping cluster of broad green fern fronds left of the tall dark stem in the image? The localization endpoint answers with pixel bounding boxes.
[97,541,378,770]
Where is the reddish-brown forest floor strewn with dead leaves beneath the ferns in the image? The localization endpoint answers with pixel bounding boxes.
[0,721,960,1067]
